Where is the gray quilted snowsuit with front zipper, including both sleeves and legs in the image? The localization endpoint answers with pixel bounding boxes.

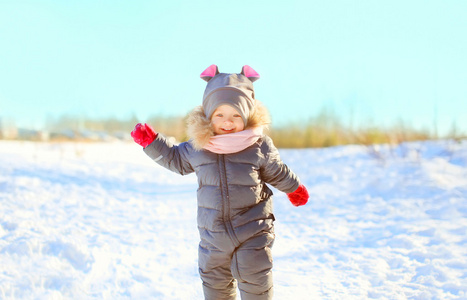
[144,134,300,300]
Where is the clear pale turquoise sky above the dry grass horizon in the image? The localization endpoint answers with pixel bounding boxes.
[0,0,467,131]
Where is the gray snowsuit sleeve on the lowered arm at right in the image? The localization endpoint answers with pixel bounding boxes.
[261,136,300,193]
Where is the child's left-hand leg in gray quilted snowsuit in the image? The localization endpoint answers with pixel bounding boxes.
[198,242,237,300]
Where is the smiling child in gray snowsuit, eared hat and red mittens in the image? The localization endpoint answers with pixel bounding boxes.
[131,65,309,300]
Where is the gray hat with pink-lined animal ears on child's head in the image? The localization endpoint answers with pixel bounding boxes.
[200,65,259,126]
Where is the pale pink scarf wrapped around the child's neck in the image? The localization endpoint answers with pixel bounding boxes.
[204,127,263,154]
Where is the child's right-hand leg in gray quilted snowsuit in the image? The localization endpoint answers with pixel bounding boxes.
[231,232,274,300]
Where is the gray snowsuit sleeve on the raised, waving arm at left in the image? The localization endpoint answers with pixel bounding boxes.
[143,133,194,175]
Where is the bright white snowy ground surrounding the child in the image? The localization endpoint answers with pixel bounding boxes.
[0,141,467,300]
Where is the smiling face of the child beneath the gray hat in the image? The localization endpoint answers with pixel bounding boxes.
[211,104,245,134]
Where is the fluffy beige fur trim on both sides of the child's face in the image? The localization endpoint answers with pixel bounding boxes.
[187,100,271,150]
